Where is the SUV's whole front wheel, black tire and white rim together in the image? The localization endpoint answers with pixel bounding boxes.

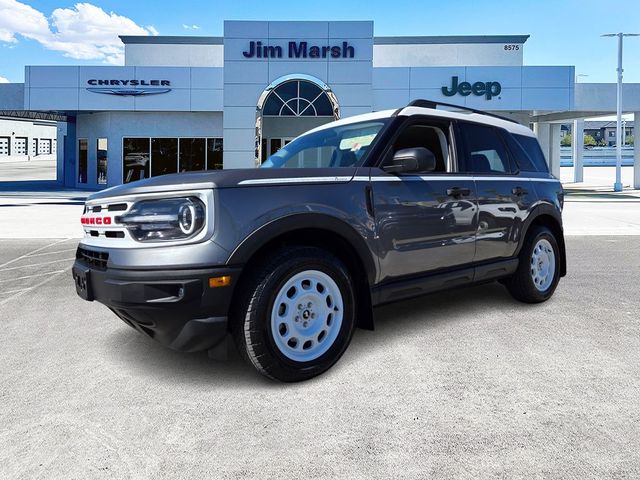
[232,247,355,382]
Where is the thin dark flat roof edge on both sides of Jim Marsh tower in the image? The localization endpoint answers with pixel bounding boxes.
[120,35,529,45]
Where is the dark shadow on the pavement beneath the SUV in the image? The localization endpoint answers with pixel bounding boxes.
[106,282,524,387]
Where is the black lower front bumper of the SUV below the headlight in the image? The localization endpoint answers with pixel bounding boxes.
[72,254,240,352]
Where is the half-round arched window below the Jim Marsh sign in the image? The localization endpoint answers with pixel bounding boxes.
[262,80,335,117]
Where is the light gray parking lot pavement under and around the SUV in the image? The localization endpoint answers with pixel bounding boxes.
[0,236,640,479]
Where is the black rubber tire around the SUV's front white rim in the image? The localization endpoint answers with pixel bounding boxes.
[231,246,356,382]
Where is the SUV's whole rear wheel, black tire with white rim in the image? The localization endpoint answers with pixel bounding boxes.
[503,226,560,303]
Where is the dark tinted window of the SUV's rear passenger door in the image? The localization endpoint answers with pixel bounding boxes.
[461,123,510,173]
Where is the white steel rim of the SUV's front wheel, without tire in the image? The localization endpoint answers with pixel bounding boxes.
[271,270,344,362]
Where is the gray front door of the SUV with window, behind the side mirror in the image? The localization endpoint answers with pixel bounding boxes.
[371,119,478,280]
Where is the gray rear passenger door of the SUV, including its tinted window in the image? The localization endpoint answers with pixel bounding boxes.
[459,122,536,262]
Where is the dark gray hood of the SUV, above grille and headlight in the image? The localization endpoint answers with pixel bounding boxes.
[87,167,356,200]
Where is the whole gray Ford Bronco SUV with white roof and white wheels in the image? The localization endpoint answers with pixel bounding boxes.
[73,100,566,381]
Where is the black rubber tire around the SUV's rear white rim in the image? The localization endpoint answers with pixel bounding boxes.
[501,225,561,303]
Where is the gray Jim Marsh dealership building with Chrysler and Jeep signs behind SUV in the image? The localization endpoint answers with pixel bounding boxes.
[0,21,640,189]
